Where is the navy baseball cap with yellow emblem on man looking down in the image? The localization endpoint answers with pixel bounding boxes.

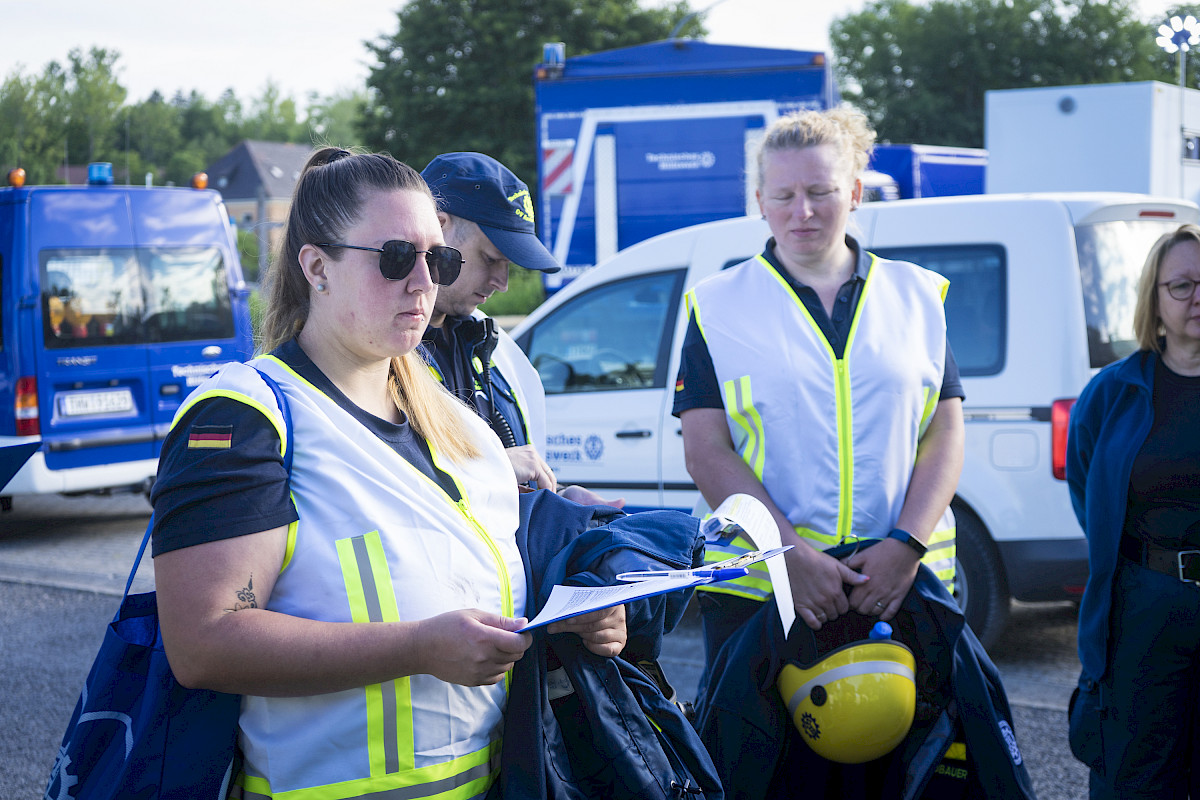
[421,152,563,272]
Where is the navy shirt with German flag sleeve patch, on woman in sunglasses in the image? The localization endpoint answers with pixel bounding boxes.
[150,339,458,555]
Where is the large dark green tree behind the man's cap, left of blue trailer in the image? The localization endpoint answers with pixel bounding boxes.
[362,0,704,182]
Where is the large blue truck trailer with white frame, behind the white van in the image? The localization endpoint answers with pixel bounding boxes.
[534,40,838,291]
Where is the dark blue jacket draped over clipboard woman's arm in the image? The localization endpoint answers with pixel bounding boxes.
[488,491,722,800]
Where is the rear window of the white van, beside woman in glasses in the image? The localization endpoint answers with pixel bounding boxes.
[1075,219,1180,367]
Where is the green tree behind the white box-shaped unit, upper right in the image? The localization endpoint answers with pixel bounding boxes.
[830,0,1170,148]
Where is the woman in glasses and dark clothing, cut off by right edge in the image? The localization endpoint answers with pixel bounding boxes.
[1067,224,1200,799]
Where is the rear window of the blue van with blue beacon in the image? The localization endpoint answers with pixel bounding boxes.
[41,247,234,348]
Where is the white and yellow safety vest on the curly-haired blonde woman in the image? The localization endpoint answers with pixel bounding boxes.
[686,254,954,600]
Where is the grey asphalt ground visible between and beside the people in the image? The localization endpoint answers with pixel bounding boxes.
[0,495,1087,800]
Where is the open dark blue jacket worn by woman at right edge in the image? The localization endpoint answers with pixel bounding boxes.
[1067,350,1158,680]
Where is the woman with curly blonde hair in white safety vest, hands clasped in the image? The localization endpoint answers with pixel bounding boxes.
[673,107,964,663]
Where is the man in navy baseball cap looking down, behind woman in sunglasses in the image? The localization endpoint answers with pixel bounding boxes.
[421,152,624,507]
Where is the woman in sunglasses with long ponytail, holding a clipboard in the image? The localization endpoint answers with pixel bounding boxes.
[145,148,625,798]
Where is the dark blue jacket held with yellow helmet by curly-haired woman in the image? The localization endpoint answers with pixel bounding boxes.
[696,545,1034,800]
